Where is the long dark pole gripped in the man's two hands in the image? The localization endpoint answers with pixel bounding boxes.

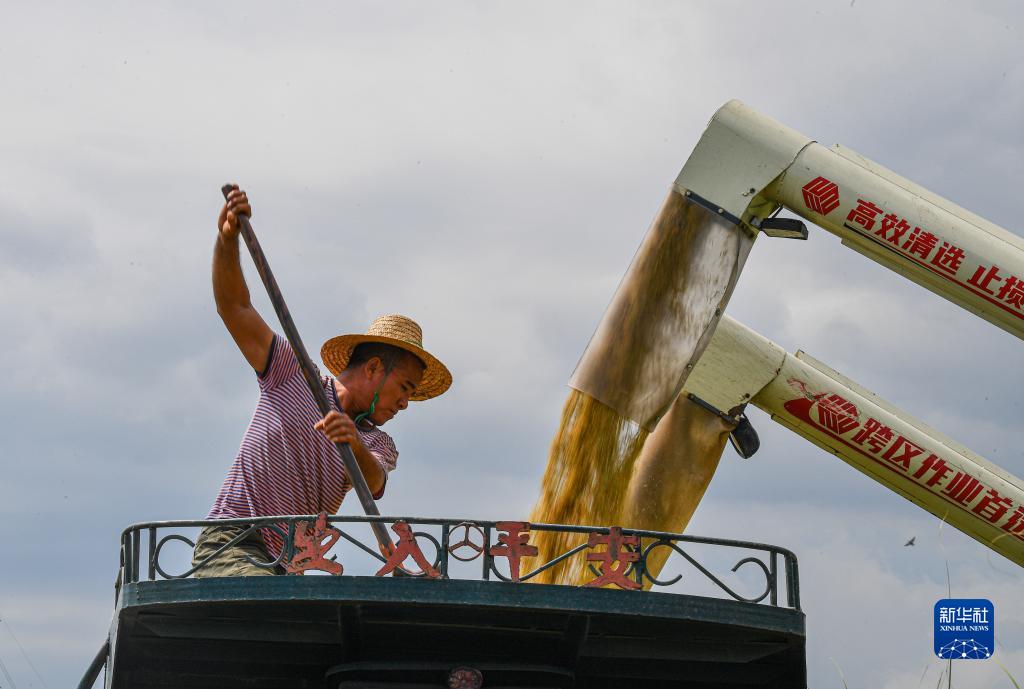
[220,184,392,553]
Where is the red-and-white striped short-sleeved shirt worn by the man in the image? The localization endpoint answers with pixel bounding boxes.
[207,335,398,558]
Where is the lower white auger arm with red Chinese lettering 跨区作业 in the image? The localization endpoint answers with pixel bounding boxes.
[679,316,1024,566]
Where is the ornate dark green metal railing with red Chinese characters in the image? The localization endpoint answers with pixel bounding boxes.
[120,515,800,610]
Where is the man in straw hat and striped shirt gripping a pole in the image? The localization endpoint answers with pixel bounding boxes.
[193,186,452,576]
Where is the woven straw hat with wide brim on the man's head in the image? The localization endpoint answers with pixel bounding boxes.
[321,313,452,401]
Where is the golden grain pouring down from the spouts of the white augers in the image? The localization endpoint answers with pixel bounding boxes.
[530,187,753,584]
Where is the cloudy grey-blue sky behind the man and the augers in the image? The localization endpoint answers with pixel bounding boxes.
[0,0,1024,689]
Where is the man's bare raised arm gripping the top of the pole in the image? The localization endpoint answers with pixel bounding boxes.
[213,186,273,372]
